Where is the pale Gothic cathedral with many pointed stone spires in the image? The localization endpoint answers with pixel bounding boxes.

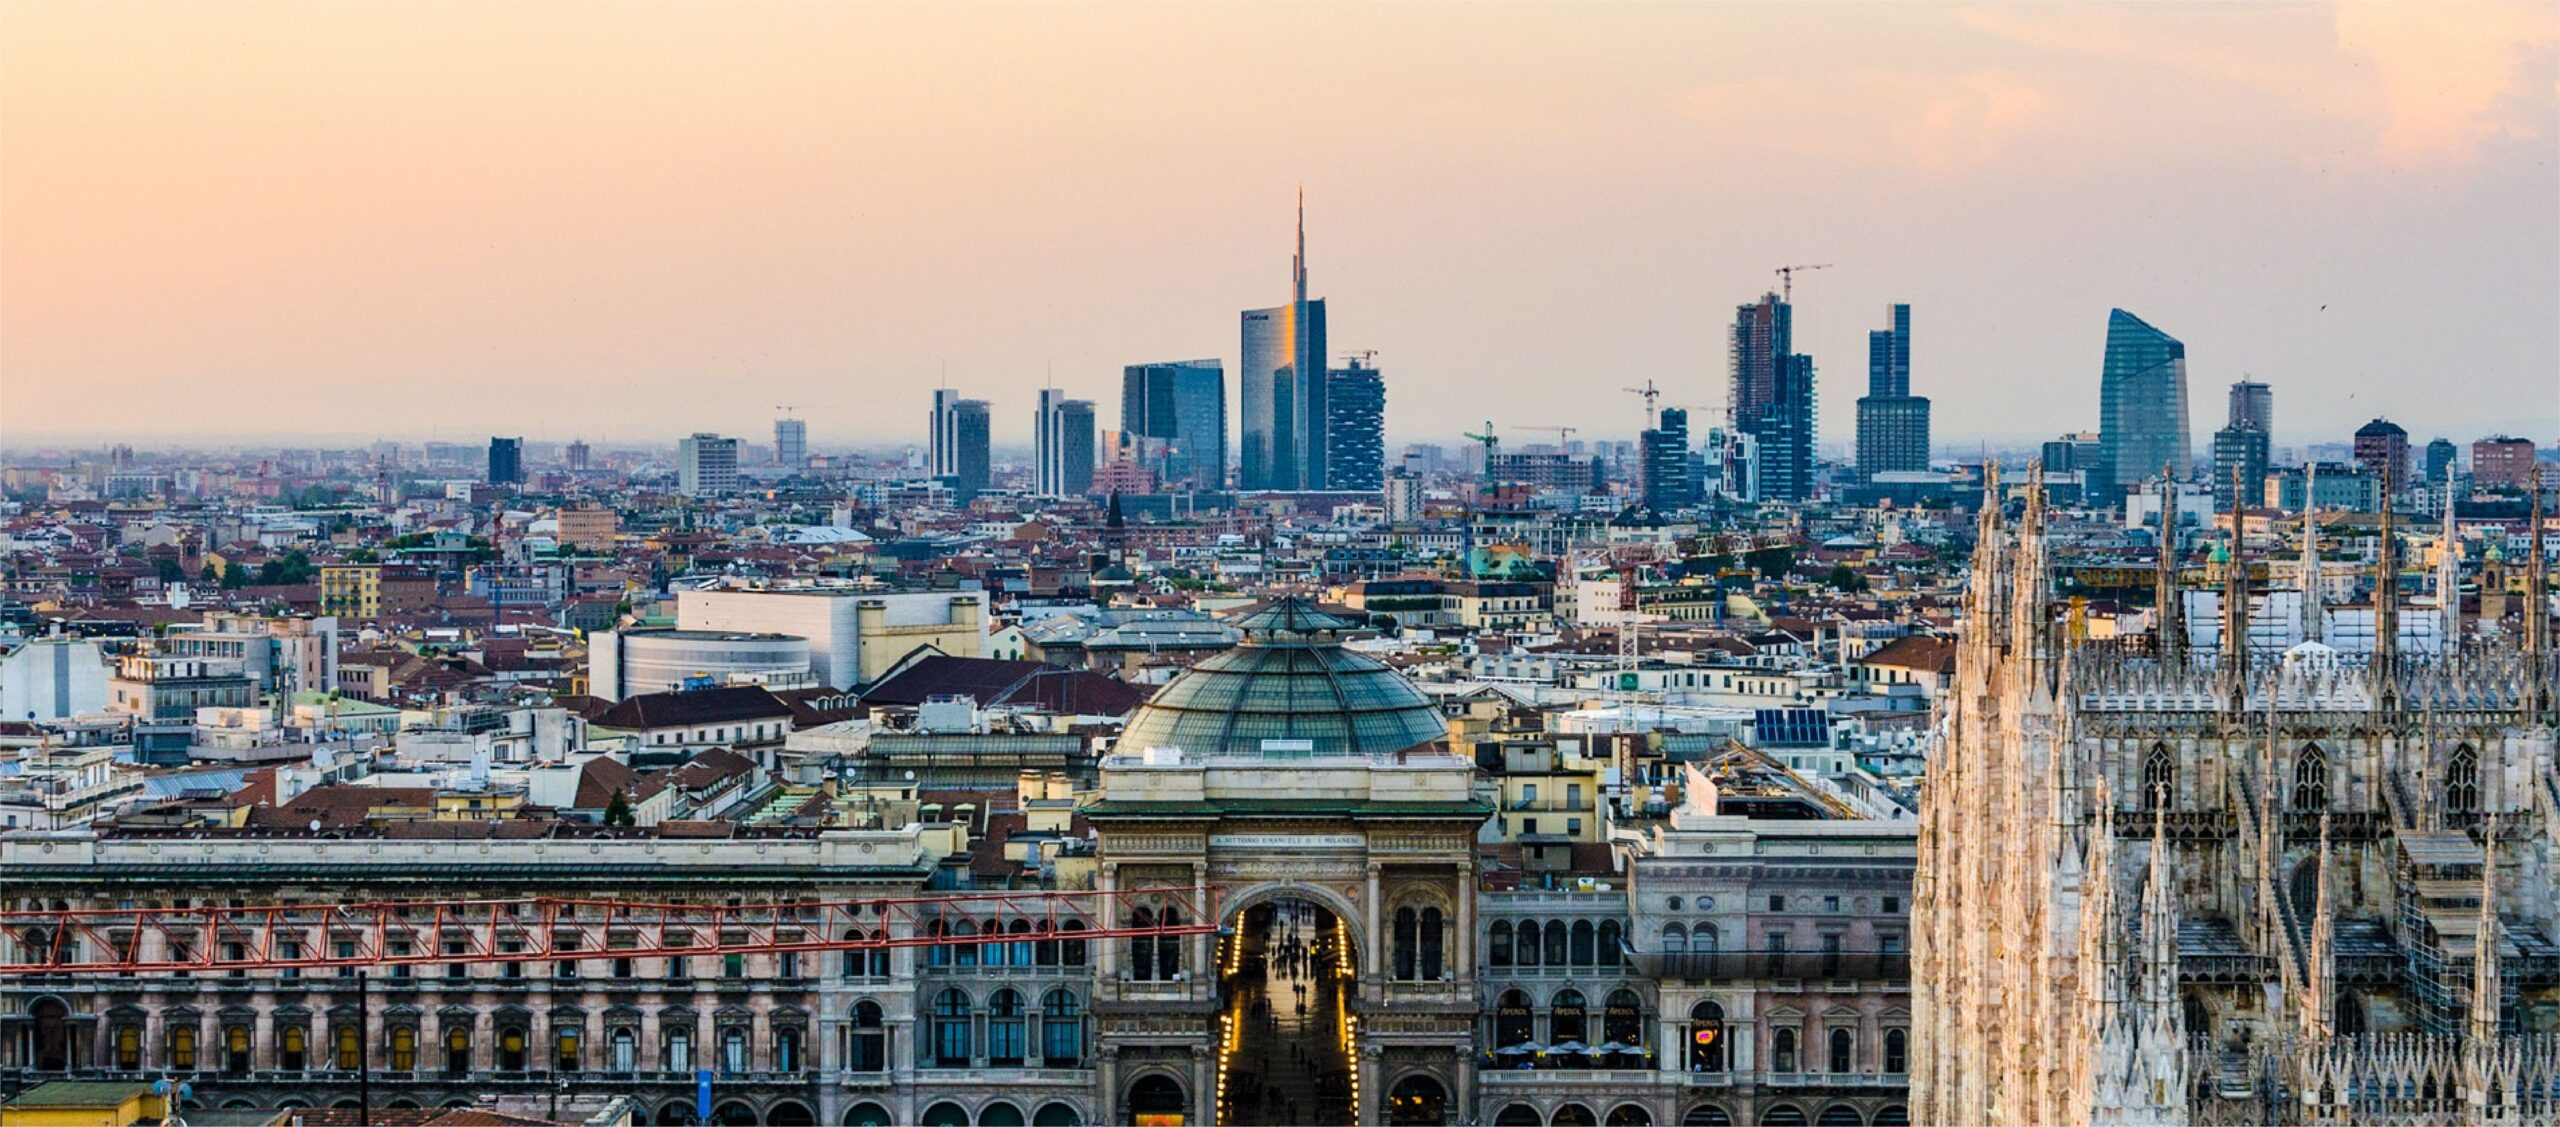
[1912,471,2560,1124]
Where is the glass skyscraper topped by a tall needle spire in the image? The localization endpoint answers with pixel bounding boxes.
[1239,192,1331,489]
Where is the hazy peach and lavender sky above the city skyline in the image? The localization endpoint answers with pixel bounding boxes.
[0,0,2560,453]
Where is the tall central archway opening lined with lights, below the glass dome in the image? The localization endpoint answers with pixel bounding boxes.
[1219,889,1361,1124]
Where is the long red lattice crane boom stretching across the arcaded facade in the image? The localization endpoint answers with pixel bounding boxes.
[0,889,1216,978]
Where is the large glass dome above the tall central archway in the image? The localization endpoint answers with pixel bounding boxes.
[1119,599,1449,756]
